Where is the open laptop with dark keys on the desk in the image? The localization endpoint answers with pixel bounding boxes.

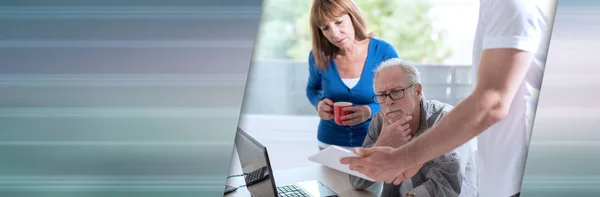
[235,127,338,197]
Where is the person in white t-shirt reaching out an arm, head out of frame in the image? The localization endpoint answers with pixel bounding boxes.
[340,0,548,197]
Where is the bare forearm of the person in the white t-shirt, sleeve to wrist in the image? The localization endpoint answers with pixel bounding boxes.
[395,49,533,167]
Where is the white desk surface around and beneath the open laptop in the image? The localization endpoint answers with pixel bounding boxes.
[225,152,382,197]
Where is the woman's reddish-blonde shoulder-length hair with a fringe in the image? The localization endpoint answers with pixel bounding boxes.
[310,0,373,70]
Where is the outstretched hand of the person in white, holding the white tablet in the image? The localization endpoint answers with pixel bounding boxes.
[340,146,422,185]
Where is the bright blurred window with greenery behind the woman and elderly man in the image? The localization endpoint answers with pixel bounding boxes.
[244,0,478,116]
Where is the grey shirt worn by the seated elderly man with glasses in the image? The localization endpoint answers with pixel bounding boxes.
[350,98,462,197]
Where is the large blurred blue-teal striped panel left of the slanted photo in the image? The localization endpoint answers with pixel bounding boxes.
[0,0,261,197]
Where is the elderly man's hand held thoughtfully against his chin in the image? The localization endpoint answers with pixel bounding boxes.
[373,116,412,148]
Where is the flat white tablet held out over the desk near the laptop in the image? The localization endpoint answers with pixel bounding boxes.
[308,145,376,182]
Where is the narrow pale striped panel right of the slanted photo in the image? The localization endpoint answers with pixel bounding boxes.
[522,0,600,197]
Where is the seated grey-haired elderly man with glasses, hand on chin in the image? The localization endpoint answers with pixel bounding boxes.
[350,58,477,197]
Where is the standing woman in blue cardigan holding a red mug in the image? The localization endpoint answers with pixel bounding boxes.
[306,0,398,149]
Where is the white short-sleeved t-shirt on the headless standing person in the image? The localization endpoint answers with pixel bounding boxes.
[473,0,547,197]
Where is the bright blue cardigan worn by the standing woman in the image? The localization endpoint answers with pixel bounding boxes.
[306,38,398,147]
